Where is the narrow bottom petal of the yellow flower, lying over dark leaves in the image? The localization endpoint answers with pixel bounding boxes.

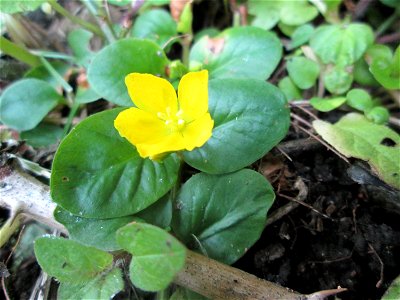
[136,132,185,159]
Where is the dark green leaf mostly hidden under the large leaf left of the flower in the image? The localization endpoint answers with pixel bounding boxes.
[54,206,135,251]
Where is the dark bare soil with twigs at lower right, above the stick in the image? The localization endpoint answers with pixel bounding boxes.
[235,147,400,299]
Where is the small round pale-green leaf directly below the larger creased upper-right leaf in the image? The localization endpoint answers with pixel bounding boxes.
[324,66,353,94]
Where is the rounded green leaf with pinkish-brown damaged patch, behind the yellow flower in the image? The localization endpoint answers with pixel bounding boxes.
[190,27,282,80]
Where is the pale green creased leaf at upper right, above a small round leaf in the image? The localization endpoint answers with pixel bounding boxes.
[310,23,374,67]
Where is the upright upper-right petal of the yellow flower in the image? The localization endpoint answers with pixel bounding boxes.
[178,70,208,121]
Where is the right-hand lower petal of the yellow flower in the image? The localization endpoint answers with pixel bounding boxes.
[182,113,214,151]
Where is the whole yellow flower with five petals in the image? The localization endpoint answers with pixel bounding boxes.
[114,70,214,158]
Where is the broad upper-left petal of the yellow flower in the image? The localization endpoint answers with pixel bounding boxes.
[125,73,178,114]
